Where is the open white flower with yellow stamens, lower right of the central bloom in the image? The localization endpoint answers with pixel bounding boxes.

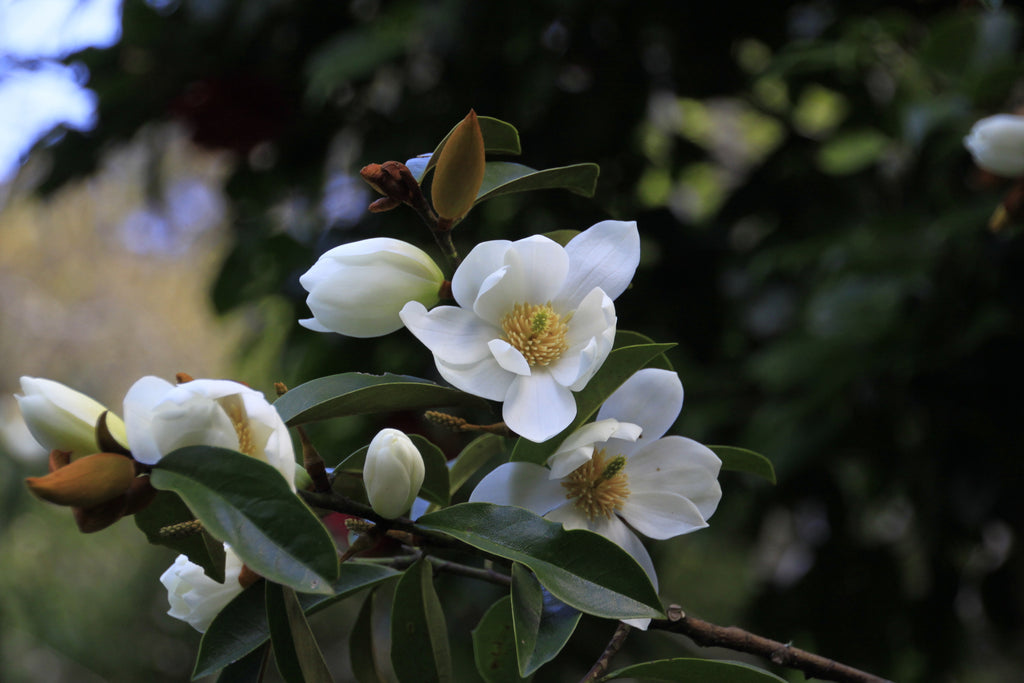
[469,369,722,628]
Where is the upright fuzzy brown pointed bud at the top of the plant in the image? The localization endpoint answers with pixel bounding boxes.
[430,110,485,222]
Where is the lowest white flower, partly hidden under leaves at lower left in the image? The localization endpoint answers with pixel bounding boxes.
[160,544,255,633]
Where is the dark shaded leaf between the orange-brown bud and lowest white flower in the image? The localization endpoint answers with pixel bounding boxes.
[134,490,224,584]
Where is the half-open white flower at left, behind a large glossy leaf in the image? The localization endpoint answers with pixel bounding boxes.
[124,376,295,490]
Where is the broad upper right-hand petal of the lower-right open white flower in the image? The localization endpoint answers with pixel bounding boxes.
[626,436,722,519]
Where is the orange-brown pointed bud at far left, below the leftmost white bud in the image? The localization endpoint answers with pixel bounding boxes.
[25,453,135,508]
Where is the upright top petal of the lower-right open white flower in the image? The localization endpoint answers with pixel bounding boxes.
[597,368,683,448]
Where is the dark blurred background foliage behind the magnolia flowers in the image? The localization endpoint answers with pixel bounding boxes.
[12,0,1024,682]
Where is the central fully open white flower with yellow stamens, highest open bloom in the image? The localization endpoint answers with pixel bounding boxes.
[401,220,640,441]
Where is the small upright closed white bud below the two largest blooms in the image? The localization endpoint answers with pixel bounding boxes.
[362,429,425,519]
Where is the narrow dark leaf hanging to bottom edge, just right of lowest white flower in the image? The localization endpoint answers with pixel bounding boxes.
[265,582,334,683]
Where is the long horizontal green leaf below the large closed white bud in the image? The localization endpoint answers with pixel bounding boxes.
[273,373,486,427]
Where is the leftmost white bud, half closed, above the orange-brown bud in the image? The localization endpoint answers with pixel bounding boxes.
[14,377,128,456]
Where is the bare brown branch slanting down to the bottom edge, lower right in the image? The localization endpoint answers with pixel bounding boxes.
[650,605,891,683]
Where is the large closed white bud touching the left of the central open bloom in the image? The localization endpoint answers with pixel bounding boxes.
[299,238,444,337]
